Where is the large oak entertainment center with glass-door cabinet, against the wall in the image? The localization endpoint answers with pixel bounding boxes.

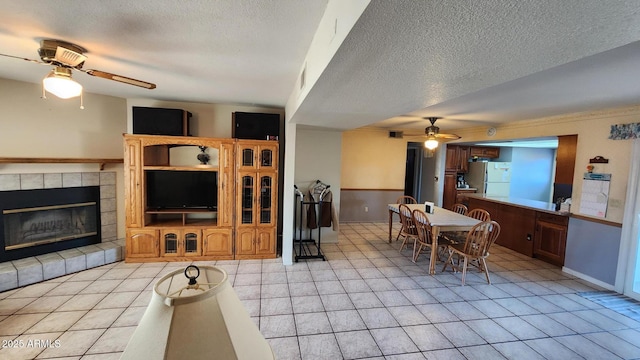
[124,134,278,262]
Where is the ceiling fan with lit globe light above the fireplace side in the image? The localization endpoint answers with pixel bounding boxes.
[0,39,156,99]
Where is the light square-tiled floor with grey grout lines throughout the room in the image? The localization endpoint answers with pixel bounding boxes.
[0,223,640,360]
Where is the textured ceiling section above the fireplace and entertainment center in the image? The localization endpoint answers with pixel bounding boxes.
[0,0,327,107]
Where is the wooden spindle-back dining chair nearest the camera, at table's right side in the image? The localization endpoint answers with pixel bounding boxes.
[442,221,500,286]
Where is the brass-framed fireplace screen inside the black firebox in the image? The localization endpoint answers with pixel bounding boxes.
[2,202,98,251]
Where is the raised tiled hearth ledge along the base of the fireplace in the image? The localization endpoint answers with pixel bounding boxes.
[0,239,124,292]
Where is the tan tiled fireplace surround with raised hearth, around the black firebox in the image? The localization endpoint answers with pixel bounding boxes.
[0,171,124,292]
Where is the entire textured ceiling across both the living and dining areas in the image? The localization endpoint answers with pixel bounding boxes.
[0,0,640,130]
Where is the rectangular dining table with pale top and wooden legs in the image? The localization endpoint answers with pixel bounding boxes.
[388,204,480,275]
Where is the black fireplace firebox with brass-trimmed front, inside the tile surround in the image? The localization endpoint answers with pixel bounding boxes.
[0,186,101,261]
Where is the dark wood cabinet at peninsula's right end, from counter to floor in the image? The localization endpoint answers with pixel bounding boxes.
[533,212,569,266]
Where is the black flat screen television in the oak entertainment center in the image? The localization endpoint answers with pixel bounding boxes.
[145,170,218,211]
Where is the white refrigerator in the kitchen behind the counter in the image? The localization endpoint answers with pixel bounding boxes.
[466,162,511,197]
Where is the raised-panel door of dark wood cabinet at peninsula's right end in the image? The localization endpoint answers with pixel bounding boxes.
[533,220,567,266]
